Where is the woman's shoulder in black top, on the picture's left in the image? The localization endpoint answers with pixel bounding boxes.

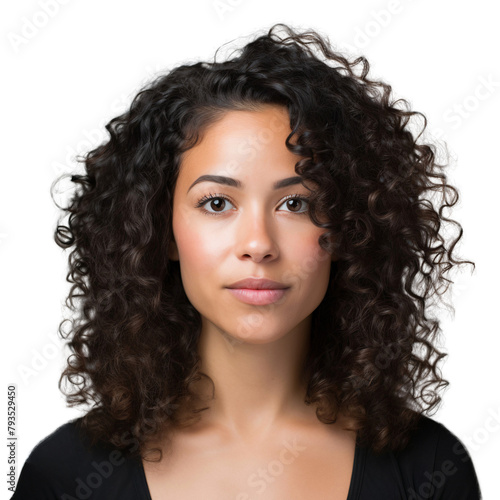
[12,418,143,500]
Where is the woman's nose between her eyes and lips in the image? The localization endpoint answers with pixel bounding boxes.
[236,208,279,262]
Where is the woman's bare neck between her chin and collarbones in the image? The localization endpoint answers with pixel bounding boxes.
[193,316,317,439]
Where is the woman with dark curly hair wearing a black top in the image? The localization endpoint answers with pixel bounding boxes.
[12,25,481,500]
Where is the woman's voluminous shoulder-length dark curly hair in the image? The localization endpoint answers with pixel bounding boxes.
[52,23,475,457]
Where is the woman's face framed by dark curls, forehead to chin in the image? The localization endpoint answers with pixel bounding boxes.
[169,105,333,343]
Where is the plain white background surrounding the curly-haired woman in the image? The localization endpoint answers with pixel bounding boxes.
[0,0,500,498]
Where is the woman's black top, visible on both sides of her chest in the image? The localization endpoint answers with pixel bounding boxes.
[11,416,482,500]
